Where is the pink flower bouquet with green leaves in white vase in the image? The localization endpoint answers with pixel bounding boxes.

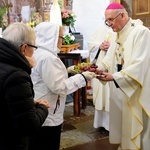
[61,9,76,28]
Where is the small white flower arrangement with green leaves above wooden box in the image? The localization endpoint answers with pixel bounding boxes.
[62,33,76,45]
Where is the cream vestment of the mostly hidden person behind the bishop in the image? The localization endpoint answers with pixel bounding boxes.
[88,25,115,130]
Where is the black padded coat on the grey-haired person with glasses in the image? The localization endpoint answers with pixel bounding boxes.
[0,38,48,150]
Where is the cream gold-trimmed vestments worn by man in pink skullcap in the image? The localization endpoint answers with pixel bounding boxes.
[99,19,150,150]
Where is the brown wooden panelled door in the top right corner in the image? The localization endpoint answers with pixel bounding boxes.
[132,0,150,27]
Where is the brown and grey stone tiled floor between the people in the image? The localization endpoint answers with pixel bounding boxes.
[60,99,118,150]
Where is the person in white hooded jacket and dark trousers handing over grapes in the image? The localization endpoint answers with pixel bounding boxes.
[31,22,95,150]
